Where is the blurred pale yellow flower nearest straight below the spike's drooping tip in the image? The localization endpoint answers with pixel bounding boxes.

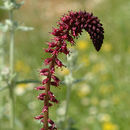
[92,63,105,73]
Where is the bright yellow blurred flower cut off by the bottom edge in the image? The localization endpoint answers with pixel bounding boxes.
[102,122,118,130]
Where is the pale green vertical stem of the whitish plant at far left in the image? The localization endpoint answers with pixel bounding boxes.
[9,10,15,129]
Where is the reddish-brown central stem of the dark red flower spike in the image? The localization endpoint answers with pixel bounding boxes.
[44,55,55,130]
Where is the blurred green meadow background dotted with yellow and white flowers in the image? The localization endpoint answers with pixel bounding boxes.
[0,0,130,130]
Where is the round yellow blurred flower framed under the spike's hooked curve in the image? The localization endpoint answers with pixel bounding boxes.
[77,40,89,50]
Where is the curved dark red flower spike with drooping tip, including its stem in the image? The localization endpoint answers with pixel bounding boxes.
[35,11,104,130]
